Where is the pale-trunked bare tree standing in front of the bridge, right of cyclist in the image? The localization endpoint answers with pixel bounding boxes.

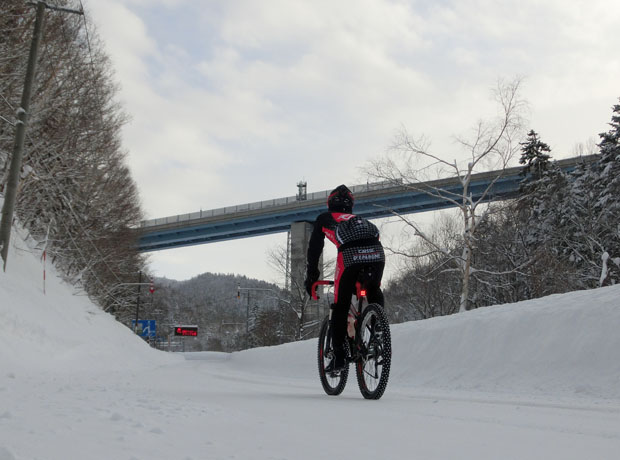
[368,79,525,312]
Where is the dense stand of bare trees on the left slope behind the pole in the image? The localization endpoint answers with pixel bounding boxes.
[0,0,145,318]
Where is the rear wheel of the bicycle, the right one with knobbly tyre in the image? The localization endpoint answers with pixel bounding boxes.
[355,303,392,399]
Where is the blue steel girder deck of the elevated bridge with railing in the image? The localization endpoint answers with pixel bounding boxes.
[138,157,592,252]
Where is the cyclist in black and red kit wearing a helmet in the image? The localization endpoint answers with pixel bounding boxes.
[305,185,385,372]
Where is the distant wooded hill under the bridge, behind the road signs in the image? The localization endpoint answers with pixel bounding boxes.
[148,273,294,351]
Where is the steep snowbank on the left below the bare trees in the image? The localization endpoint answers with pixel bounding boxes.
[0,226,177,371]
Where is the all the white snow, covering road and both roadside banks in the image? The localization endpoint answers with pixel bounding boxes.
[0,228,620,460]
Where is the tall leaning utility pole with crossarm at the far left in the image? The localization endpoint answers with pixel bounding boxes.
[0,0,84,271]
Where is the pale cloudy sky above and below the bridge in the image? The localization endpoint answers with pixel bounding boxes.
[83,0,620,280]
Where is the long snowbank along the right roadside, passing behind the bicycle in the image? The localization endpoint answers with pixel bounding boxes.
[211,286,620,399]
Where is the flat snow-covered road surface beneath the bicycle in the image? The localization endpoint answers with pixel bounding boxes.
[0,352,620,460]
